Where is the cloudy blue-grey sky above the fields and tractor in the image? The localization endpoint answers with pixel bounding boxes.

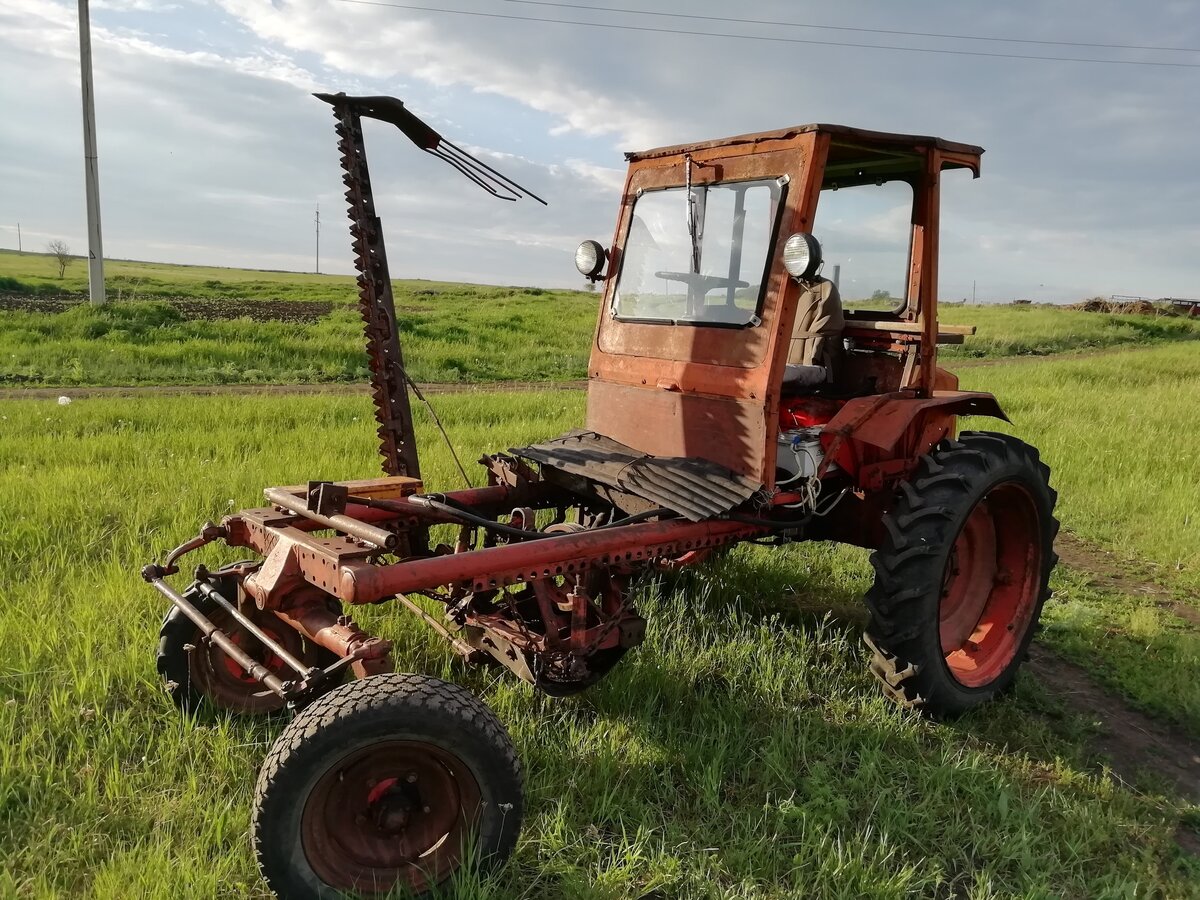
[0,0,1200,302]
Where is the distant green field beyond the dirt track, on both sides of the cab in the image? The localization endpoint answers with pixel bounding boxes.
[0,252,1200,386]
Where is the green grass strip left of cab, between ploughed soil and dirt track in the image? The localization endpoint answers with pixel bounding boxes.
[0,296,595,386]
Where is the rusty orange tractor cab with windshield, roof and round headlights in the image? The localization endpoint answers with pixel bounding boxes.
[564,125,983,488]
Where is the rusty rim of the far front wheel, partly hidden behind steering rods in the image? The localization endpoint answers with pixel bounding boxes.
[187,608,305,713]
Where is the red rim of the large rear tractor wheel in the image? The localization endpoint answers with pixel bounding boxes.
[938,482,1042,688]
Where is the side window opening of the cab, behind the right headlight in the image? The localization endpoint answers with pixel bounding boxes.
[816,181,913,310]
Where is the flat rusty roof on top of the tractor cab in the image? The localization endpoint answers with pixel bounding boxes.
[625,122,983,186]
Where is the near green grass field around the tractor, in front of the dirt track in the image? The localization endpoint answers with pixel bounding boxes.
[0,340,1200,899]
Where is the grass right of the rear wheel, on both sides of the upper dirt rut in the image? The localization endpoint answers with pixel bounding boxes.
[962,346,1200,737]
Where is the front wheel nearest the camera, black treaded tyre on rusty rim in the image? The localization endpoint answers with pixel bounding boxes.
[250,674,523,900]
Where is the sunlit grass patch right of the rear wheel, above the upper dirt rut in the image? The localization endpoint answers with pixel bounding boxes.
[961,344,1200,590]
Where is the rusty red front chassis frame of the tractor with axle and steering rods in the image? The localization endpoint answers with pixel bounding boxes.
[142,476,794,708]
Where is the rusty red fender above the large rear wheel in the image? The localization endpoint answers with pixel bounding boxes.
[821,391,1009,491]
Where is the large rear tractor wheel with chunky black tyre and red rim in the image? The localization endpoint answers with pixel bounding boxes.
[865,432,1058,716]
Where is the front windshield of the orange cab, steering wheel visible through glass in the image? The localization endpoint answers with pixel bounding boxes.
[612,179,784,325]
